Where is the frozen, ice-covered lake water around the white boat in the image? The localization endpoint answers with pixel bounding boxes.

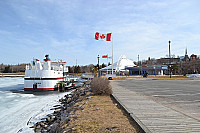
[0,77,70,133]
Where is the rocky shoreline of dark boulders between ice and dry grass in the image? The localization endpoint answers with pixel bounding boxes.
[31,86,91,133]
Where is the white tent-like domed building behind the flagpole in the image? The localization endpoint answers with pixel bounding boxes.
[100,55,136,75]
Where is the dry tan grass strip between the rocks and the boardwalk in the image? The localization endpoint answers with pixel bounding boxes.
[65,96,136,133]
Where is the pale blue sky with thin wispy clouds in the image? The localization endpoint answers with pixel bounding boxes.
[0,0,200,65]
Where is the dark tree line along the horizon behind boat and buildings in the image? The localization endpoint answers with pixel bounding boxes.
[0,57,200,75]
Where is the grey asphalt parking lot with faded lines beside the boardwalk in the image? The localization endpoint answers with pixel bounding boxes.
[115,79,200,120]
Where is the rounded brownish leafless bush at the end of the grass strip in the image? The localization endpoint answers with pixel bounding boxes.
[90,77,112,95]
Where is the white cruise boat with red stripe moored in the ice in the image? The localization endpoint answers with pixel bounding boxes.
[24,55,68,91]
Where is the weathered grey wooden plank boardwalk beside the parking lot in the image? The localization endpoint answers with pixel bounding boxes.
[110,81,200,133]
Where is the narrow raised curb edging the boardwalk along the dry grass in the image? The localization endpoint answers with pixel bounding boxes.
[111,94,152,133]
